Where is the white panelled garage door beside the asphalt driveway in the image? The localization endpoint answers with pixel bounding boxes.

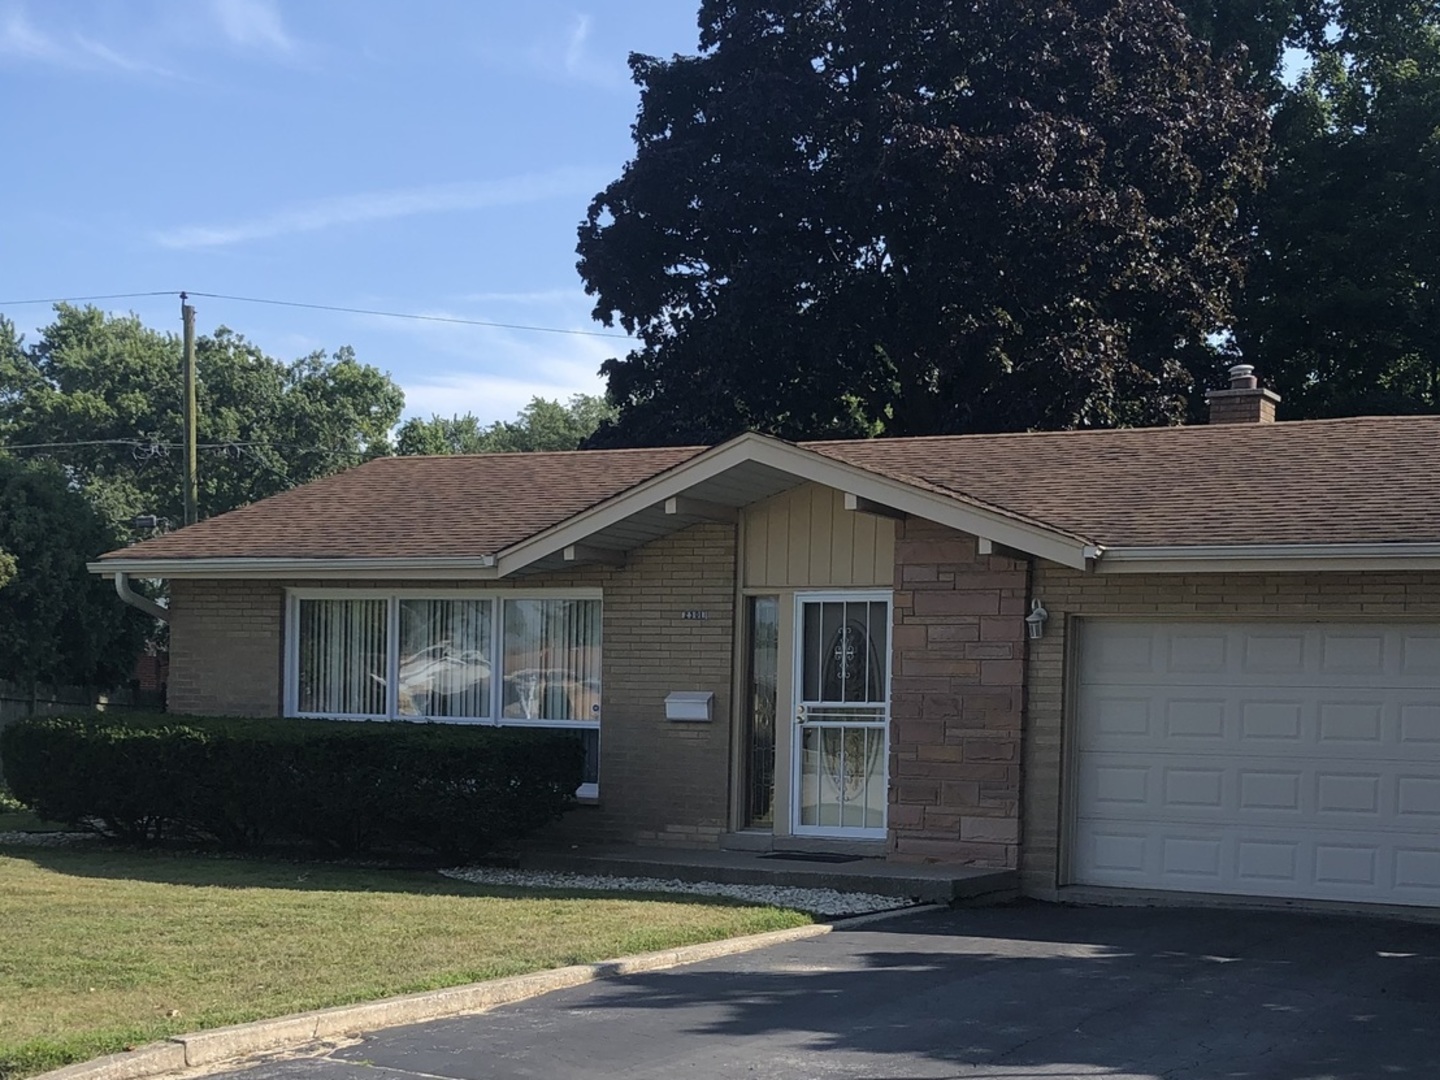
[1071,619,1440,906]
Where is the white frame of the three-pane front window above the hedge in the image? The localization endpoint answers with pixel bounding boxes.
[284,588,605,798]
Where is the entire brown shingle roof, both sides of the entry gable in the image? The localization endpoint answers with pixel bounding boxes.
[105,416,1440,559]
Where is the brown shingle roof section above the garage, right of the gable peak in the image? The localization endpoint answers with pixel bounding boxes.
[806,416,1440,547]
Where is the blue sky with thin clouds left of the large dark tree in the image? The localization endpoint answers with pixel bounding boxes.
[0,0,698,420]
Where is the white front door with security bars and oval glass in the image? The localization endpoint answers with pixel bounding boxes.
[792,592,890,840]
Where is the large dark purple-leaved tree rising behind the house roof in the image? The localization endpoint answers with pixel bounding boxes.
[579,0,1267,445]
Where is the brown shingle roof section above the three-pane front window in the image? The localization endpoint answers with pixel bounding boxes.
[102,446,704,559]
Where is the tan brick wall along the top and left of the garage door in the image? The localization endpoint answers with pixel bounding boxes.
[1021,560,1440,896]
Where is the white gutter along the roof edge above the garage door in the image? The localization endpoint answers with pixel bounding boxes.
[1094,543,1440,573]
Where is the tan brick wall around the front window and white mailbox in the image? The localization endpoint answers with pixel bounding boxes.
[170,526,736,847]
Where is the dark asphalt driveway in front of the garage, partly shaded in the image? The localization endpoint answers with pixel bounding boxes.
[210,903,1440,1080]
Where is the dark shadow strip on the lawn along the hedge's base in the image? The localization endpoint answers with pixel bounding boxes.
[0,840,777,907]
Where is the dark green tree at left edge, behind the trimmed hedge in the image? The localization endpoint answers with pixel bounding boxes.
[0,455,154,691]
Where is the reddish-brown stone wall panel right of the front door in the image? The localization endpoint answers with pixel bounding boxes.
[888,518,1027,867]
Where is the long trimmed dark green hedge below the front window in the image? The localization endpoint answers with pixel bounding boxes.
[0,714,583,858]
